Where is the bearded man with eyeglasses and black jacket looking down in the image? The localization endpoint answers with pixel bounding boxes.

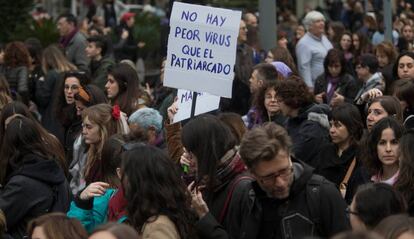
[233,123,349,239]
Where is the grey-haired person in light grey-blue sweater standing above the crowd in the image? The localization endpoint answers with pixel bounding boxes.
[296,11,332,91]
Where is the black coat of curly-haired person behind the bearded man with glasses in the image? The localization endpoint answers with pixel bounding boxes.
[286,104,330,168]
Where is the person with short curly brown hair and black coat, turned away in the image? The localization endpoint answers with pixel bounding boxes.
[275,77,330,167]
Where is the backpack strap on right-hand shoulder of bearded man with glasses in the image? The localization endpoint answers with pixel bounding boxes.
[306,174,325,230]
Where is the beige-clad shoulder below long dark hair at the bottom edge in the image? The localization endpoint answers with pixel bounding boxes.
[142,215,180,239]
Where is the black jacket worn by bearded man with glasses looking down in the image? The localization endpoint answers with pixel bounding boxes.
[194,162,350,239]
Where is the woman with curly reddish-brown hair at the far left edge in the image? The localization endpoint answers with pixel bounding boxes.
[4,41,31,105]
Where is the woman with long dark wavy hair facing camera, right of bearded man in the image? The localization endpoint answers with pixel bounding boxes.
[362,117,404,185]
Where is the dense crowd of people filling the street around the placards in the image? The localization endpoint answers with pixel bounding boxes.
[0,1,414,239]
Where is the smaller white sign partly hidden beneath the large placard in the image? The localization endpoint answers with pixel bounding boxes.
[174,89,220,123]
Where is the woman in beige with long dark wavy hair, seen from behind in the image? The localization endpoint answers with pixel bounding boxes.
[121,144,196,239]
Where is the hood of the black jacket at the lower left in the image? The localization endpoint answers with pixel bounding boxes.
[10,153,65,185]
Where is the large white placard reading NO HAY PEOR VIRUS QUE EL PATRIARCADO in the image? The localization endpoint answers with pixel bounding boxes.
[164,2,241,98]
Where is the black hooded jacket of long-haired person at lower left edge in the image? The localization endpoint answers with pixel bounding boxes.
[0,153,70,239]
